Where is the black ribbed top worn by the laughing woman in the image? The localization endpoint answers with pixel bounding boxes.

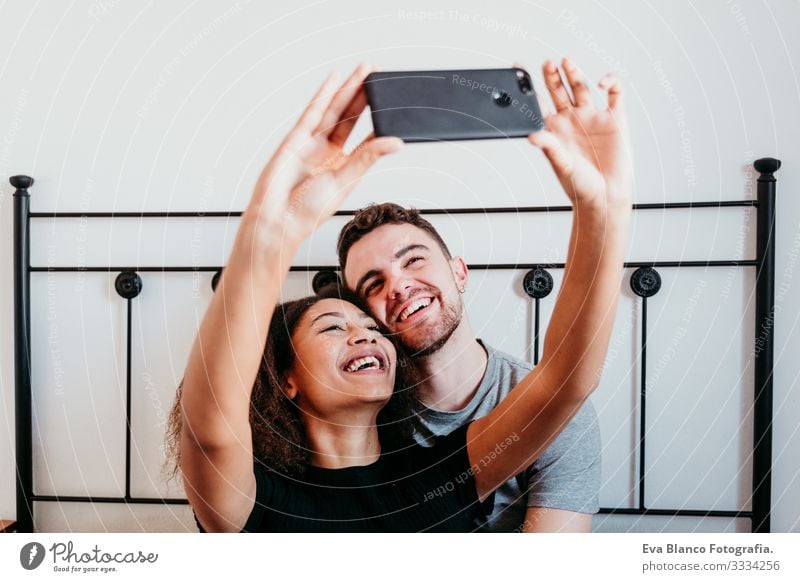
[195,425,492,532]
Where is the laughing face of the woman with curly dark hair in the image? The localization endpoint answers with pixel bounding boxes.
[287,299,397,418]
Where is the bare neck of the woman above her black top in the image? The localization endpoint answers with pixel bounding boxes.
[303,409,381,469]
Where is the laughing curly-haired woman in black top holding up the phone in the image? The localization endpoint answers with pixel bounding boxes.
[166,66,631,532]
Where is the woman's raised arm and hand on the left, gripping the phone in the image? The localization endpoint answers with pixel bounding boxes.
[180,65,402,531]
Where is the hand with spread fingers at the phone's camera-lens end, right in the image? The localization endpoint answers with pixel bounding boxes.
[528,58,633,207]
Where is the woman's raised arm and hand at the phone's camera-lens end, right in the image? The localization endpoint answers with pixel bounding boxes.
[467,59,633,498]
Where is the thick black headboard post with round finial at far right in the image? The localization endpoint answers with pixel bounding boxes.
[752,158,781,533]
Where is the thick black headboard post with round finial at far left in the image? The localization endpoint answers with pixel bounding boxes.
[9,176,33,533]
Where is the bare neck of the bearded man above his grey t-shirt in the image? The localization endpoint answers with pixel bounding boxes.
[414,316,489,412]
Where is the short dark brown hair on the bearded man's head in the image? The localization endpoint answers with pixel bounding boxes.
[336,202,453,277]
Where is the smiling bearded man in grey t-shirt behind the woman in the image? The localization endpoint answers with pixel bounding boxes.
[339,203,600,532]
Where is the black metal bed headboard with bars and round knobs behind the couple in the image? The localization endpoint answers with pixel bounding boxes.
[10,158,781,533]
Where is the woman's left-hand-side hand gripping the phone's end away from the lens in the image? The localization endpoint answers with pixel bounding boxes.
[245,65,403,250]
